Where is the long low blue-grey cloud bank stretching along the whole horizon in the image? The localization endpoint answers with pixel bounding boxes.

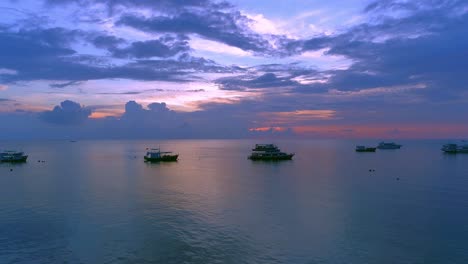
[0,99,468,139]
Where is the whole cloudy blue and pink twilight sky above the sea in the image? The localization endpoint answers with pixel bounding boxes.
[0,0,468,139]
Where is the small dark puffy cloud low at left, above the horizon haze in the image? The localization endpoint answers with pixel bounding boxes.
[41,100,91,125]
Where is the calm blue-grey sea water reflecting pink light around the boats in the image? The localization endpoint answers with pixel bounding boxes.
[0,140,468,264]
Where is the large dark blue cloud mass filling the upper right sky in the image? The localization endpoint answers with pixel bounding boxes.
[268,0,468,100]
